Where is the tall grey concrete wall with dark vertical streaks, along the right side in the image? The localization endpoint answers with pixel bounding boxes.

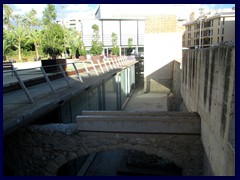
[181,43,235,176]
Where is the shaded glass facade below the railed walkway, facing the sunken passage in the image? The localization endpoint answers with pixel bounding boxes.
[69,65,135,123]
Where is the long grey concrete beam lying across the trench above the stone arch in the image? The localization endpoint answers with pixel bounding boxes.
[76,111,201,134]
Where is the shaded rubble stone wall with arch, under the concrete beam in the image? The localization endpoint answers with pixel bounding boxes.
[4,124,203,176]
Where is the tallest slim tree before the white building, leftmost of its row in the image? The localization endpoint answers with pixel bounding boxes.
[90,24,103,56]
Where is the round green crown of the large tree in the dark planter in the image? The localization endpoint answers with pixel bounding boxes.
[42,24,64,59]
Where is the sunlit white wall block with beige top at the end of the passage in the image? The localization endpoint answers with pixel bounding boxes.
[144,16,182,93]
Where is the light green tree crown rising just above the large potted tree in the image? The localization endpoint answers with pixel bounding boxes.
[42,4,57,26]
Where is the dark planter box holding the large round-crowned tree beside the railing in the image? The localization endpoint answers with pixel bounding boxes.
[41,59,67,73]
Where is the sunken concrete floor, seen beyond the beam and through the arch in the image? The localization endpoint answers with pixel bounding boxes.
[81,83,170,176]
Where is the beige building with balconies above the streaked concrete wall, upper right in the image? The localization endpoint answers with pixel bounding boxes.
[182,9,235,48]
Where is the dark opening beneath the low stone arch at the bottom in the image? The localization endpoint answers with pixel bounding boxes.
[57,150,182,176]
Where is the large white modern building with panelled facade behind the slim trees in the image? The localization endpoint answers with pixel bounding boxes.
[58,4,193,55]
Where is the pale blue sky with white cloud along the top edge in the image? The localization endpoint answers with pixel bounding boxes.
[9,4,235,19]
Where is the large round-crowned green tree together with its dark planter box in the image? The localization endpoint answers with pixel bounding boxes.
[41,24,66,73]
